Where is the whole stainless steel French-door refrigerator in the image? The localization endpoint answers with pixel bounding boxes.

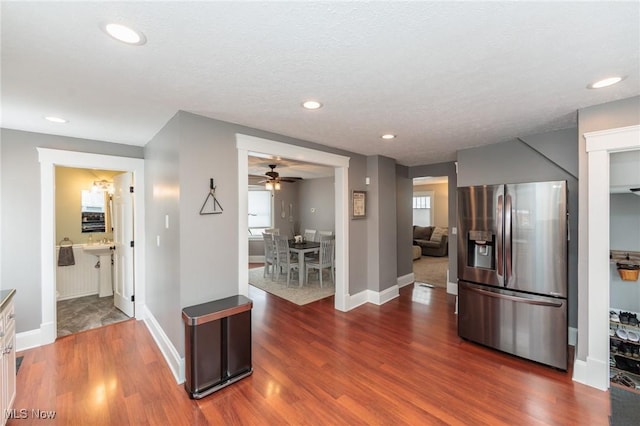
[458,181,568,370]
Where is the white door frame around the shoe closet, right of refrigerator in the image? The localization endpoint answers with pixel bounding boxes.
[573,126,640,390]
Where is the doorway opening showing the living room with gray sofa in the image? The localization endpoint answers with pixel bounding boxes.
[412,176,449,289]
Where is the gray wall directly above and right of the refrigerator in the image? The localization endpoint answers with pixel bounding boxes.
[458,129,578,327]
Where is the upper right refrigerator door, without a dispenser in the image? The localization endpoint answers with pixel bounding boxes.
[504,181,567,297]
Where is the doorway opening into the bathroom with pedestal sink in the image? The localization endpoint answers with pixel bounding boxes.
[55,166,133,337]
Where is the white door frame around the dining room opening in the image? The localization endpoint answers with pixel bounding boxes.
[236,133,351,312]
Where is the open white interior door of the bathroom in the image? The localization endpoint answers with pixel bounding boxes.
[113,173,134,317]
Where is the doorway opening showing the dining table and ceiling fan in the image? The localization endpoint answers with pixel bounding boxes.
[248,154,335,305]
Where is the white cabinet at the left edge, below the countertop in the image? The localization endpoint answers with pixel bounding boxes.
[0,289,16,425]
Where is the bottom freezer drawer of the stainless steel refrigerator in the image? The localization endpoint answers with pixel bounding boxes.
[458,281,568,370]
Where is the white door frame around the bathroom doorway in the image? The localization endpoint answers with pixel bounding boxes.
[36,148,145,347]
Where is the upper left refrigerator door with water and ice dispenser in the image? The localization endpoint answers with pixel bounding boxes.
[458,185,504,285]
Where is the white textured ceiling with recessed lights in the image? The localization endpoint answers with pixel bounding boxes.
[0,1,640,166]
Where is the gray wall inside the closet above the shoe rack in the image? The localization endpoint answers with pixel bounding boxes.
[609,193,640,312]
